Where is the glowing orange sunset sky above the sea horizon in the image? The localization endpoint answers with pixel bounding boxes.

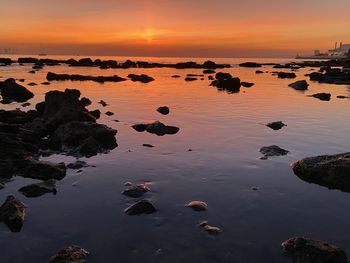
[0,0,350,57]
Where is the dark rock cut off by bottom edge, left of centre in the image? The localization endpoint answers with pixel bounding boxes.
[49,246,89,263]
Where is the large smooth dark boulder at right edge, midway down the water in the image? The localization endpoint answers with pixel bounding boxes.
[292,153,350,192]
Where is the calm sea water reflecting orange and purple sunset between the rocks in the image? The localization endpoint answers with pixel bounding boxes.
[0,56,350,263]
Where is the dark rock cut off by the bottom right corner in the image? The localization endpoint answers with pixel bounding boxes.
[282,237,348,263]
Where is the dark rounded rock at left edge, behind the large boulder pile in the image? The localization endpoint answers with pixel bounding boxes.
[0,79,34,102]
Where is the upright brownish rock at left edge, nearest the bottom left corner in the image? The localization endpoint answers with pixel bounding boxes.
[0,195,25,232]
